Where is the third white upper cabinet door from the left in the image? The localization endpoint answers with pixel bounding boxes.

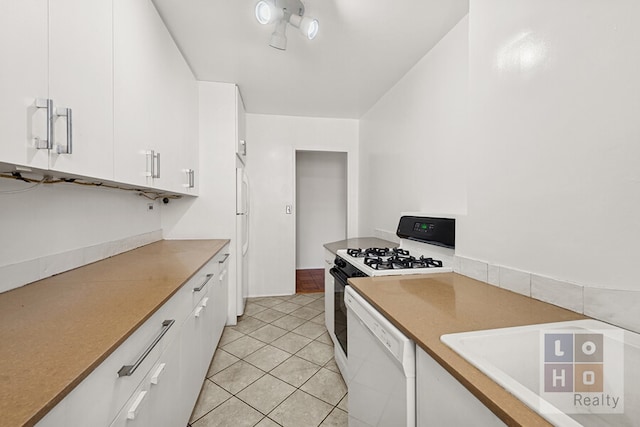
[113,0,169,187]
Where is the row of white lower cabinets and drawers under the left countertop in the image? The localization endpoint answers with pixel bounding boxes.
[36,245,229,427]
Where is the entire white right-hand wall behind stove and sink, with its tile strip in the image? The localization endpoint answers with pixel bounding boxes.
[360,0,640,331]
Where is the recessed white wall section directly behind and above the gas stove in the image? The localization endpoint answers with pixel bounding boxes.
[360,17,468,236]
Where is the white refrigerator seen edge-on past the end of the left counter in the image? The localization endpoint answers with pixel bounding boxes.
[236,160,250,316]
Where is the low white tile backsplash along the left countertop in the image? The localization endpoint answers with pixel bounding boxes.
[0,230,162,292]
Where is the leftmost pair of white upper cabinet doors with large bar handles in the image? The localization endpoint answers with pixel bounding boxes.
[0,0,113,179]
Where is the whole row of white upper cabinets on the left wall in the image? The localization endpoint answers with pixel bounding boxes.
[0,0,198,195]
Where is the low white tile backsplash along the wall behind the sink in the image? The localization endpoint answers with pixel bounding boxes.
[454,255,640,333]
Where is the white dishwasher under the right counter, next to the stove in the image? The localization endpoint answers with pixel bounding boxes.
[344,286,416,427]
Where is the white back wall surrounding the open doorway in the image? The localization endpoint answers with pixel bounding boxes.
[247,114,358,296]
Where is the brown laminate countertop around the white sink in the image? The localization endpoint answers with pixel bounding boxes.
[349,273,585,426]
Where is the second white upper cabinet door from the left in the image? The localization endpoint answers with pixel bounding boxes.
[49,0,113,179]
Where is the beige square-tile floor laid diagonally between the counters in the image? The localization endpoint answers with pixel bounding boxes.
[189,293,348,427]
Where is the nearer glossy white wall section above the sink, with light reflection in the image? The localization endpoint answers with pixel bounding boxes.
[457,0,640,329]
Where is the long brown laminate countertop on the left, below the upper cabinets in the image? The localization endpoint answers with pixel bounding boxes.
[0,240,229,427]
